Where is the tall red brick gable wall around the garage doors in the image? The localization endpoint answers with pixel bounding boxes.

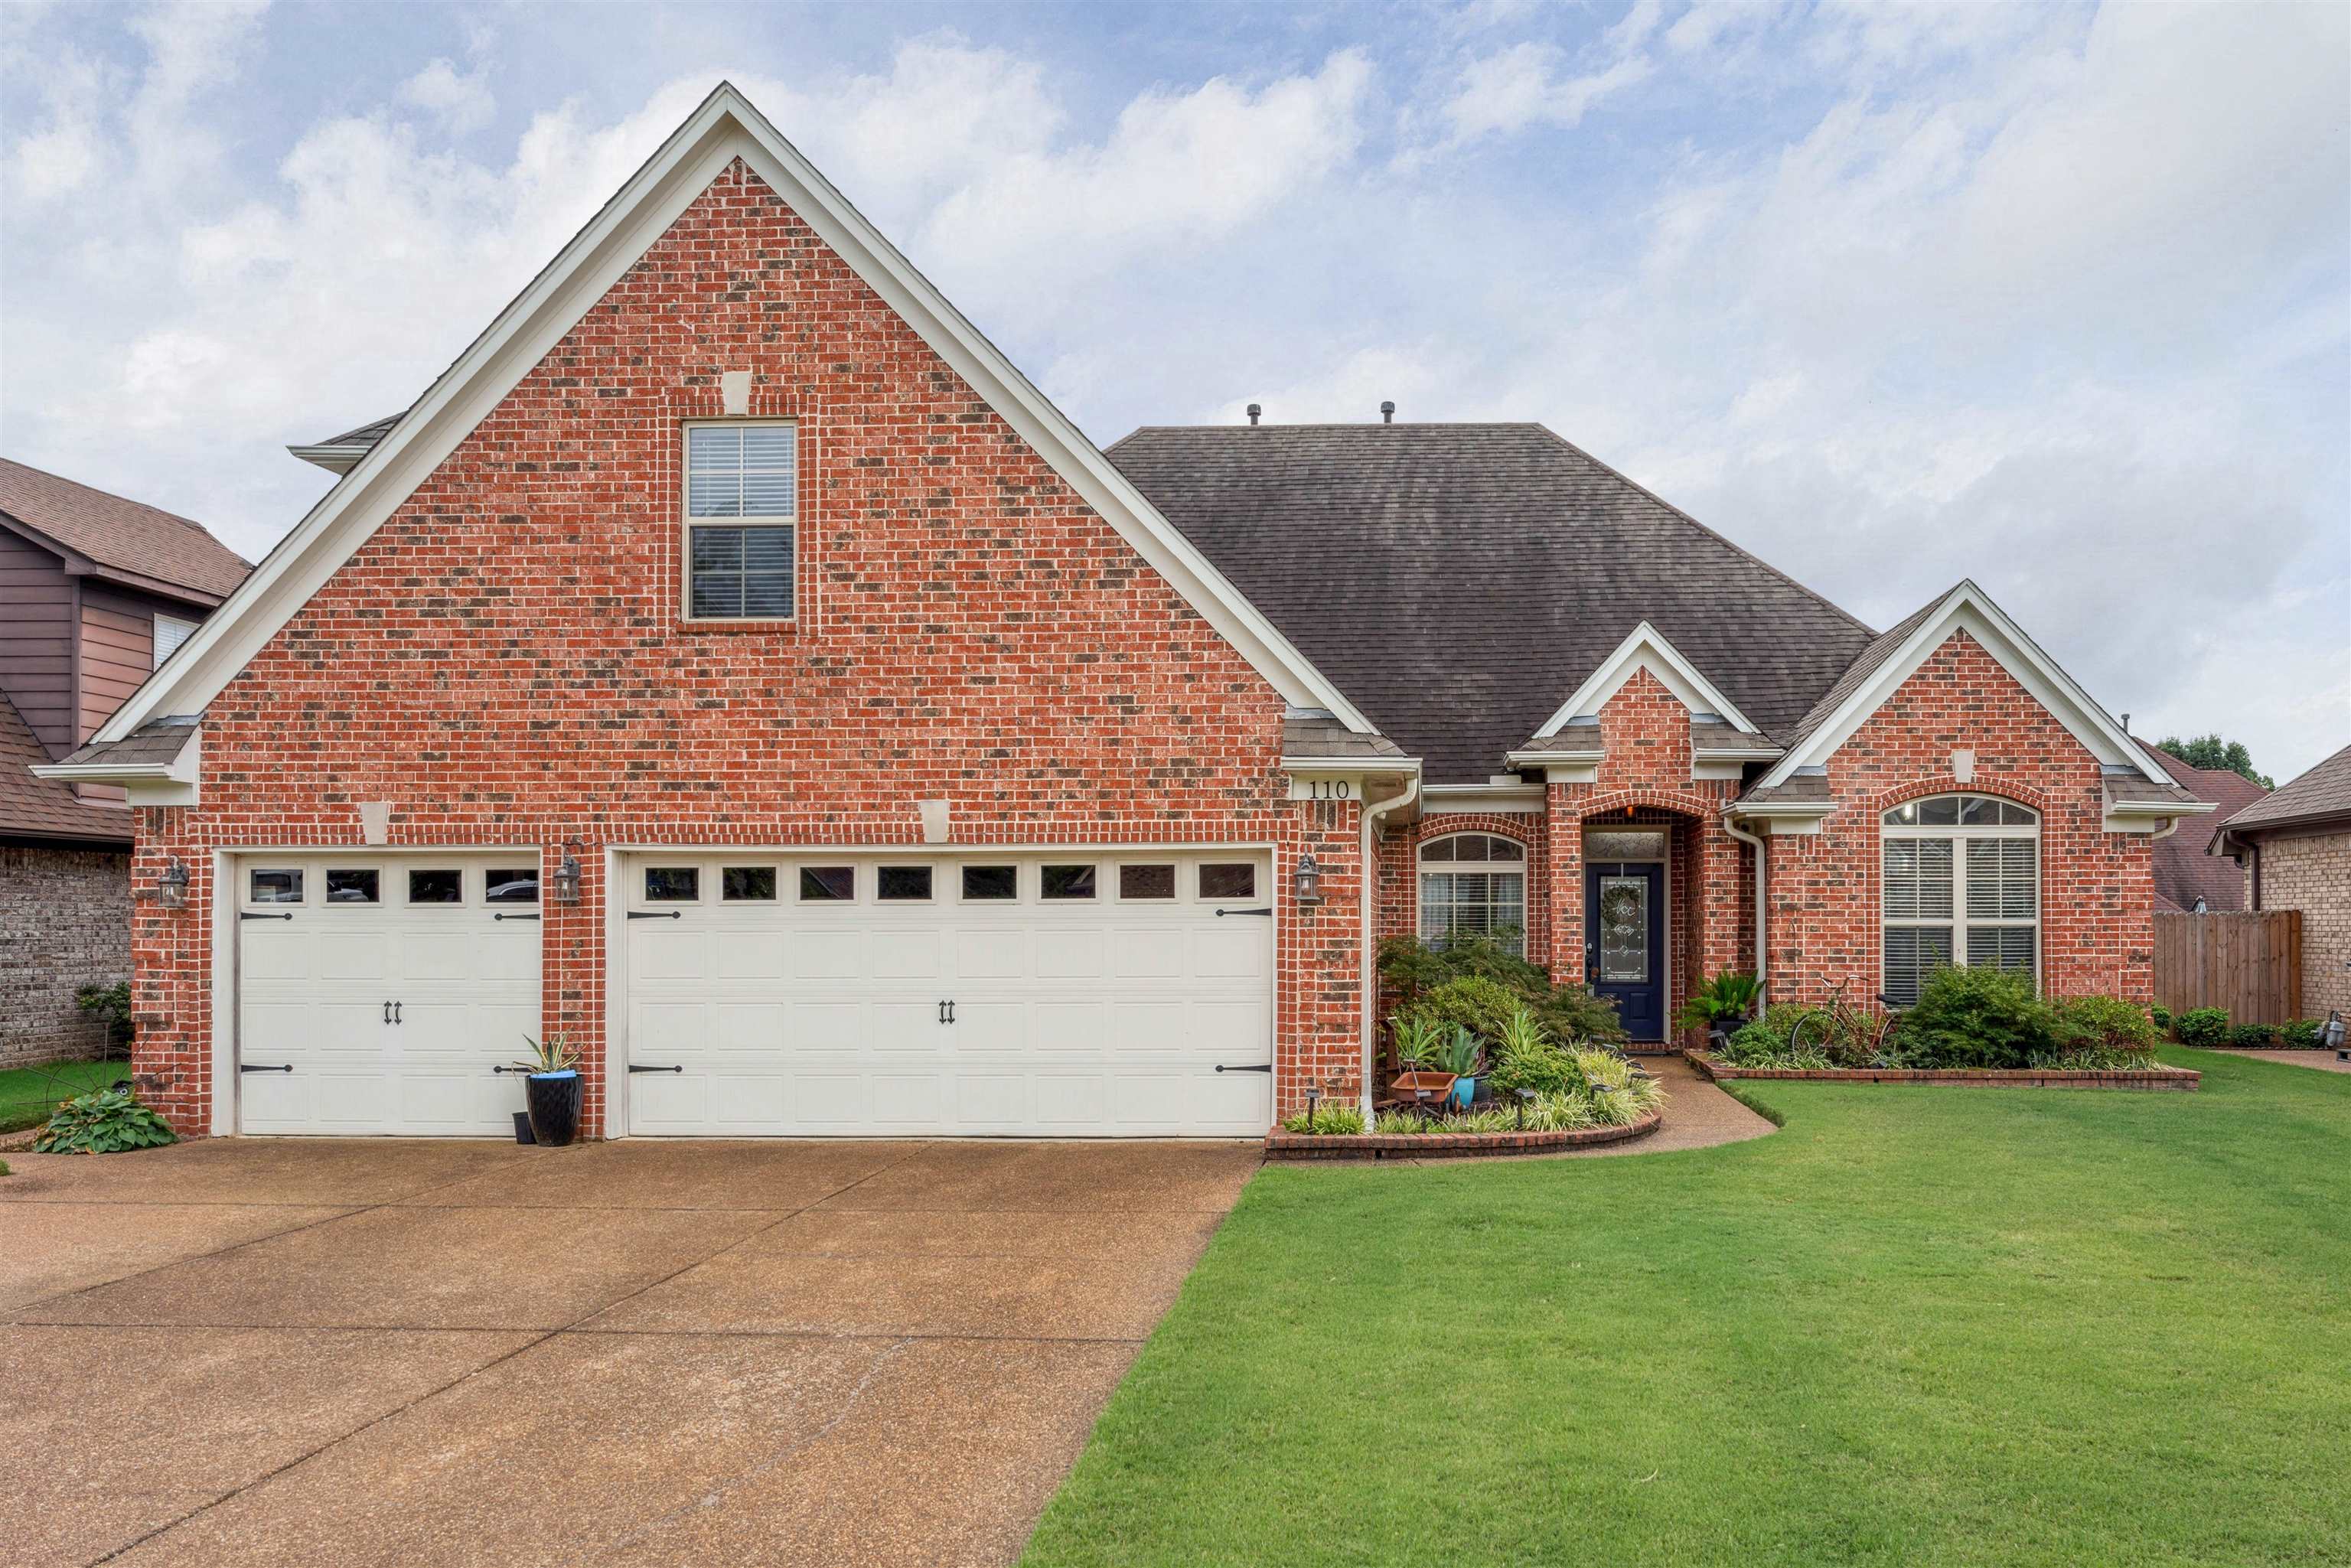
[134,165,1361,1131]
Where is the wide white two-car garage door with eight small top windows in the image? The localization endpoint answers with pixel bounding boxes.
[623,851,1274,1138]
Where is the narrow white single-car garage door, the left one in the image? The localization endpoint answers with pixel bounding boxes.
[237,849,538,1136]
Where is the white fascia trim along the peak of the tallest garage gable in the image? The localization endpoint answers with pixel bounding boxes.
[96,83,1375,741]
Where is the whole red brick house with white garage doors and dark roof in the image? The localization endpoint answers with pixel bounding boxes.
[50,87,2210,1136]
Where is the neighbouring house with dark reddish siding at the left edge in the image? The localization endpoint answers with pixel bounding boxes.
[0,458,247,1065]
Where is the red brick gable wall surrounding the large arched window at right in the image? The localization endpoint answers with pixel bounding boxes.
[1768,632,2154,1002]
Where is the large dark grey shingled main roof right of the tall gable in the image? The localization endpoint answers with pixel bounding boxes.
[1107,423,1871,783]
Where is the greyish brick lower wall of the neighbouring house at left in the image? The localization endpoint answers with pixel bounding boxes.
[0,846,132,1068]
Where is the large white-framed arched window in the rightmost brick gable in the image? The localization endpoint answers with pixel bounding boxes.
[1883,794,2040,1006]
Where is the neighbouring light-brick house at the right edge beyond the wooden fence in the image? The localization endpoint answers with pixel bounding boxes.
[2212,745,2351,1018]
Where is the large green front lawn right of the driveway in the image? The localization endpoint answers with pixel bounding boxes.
[1025,1051,2351,1568]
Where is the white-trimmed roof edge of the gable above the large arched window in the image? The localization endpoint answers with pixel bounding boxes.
[1749,579,2163,811]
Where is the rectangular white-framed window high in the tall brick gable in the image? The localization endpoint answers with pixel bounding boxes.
[686,423,799,621]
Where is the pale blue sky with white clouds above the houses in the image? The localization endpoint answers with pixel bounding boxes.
[0,0,2351,778]
